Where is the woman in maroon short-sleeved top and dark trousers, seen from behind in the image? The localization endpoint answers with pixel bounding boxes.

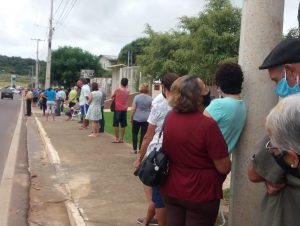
[160,75,231,226]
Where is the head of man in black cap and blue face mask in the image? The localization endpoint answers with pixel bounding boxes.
[259,38,300,97]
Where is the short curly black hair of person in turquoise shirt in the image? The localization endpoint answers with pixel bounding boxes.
[215,63,244,94]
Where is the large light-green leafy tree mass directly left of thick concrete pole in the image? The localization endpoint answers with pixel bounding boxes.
[138,0,241,79]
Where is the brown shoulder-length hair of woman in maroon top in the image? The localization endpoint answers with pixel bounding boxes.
[169,75,203,113]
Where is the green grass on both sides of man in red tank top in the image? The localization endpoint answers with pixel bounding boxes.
[104,111,132,144]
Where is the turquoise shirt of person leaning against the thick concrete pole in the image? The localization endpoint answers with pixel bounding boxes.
[205,97,247,154]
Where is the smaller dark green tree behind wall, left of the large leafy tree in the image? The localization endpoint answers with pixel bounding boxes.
[118,38,149,65]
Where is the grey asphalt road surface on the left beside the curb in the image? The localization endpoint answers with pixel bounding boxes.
[0,94,29,226]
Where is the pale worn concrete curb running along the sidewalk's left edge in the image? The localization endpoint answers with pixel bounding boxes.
[33,113,86,226]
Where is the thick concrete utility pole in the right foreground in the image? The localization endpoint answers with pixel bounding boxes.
[229,0,284,226]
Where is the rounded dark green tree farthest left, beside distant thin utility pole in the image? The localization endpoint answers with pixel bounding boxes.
[51,46,104,87]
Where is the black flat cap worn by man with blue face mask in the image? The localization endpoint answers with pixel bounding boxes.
[259,38,300,70]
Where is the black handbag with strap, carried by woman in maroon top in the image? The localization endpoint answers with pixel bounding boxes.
[138,112,169,187]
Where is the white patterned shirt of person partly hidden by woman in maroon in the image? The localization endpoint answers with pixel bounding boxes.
[146,95,171,156]
